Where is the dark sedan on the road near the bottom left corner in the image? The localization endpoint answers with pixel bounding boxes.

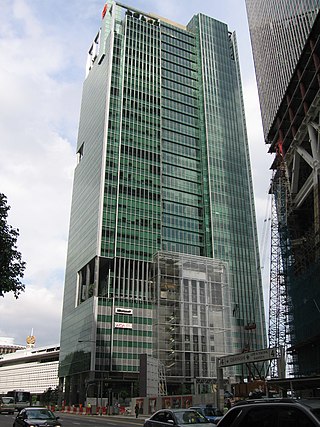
[13,407,62,427]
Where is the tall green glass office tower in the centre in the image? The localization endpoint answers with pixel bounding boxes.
[59,1,265,402]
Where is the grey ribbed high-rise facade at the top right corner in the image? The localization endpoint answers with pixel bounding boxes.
[246,0,320,137]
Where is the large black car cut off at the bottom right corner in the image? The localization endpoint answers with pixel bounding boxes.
[218,399,320,427]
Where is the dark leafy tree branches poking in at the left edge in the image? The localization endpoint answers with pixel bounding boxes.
[0,193,26,298]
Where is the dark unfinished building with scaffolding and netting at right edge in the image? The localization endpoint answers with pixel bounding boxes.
[268,11,320,375]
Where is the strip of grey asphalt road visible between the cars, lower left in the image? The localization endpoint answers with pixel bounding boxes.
[0,412,144,427]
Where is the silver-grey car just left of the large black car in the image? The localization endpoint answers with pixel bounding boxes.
[143,409,215,427]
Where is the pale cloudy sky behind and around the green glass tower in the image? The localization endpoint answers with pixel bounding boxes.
[0,0,272,346]
